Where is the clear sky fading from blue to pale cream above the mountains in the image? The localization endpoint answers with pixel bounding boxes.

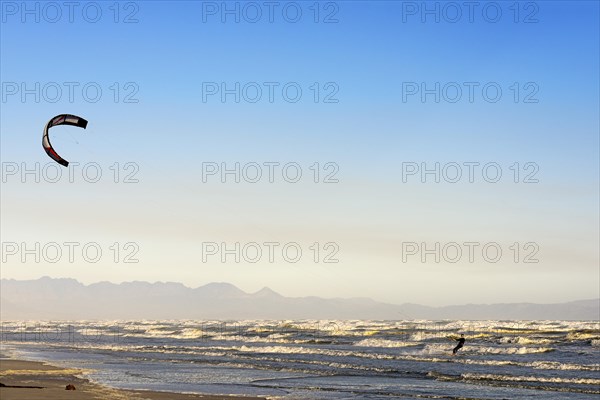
[0,1,600,305]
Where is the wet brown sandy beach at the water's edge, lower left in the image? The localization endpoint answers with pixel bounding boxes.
[0,359,264,400]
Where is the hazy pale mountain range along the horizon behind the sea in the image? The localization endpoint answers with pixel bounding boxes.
[0,277,600,321]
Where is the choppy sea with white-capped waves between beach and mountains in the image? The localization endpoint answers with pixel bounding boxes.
[1,320,600,399]
